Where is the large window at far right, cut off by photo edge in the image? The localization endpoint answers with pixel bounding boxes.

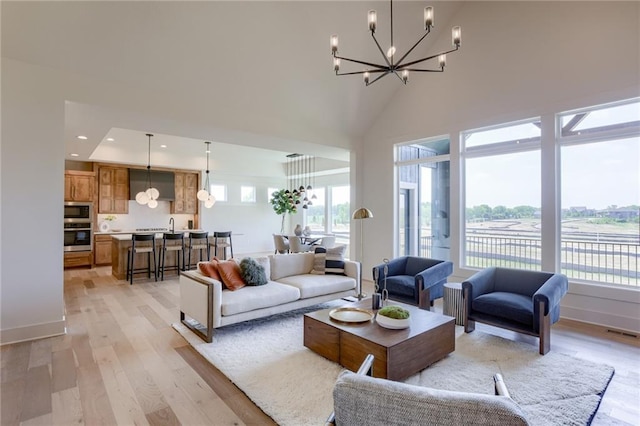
[556,100,640,286]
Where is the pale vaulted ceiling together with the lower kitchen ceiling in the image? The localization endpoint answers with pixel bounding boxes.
[0,1,460,173]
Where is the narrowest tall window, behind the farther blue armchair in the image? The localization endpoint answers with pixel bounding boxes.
[396,136,450,260]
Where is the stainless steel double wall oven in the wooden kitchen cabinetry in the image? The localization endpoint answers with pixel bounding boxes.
[64,202,93,251]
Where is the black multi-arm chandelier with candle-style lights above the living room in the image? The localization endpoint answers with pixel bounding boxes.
[331,0,462,86]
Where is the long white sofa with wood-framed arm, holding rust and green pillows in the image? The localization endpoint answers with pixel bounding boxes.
[180,252,360,342]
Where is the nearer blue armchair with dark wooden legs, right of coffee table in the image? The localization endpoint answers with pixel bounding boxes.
[462,267,569,355]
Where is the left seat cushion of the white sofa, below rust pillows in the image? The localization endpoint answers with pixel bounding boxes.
[221,281,300,316]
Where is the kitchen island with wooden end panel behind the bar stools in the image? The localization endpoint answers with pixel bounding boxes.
[111,230,209,280]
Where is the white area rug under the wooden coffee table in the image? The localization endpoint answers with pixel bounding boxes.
[173,302,613,426]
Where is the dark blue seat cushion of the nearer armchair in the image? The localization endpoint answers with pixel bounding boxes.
[471,291,533,326]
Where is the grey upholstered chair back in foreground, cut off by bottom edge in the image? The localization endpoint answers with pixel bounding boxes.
[333,371,528,426]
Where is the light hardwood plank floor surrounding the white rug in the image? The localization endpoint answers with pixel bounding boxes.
[0,267,640,425]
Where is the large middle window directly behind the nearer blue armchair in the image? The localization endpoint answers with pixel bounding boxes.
[461,119,542,270]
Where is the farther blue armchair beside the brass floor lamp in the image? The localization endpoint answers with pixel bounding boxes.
[373,256,453,310]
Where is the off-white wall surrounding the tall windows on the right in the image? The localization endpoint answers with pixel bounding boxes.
[357,2,640,331]
